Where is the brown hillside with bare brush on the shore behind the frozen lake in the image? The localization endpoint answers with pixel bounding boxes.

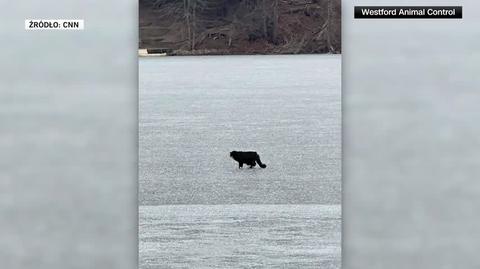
[139,0,341,54]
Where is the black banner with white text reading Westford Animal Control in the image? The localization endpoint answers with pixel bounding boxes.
[355,6,462,19]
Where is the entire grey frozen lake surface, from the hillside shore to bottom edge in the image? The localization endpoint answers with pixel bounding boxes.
[139,55,341,269]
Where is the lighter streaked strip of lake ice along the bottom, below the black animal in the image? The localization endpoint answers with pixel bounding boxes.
[139,205,341,269]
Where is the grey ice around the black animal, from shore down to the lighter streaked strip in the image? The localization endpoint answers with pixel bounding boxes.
[139,55,341,205]
